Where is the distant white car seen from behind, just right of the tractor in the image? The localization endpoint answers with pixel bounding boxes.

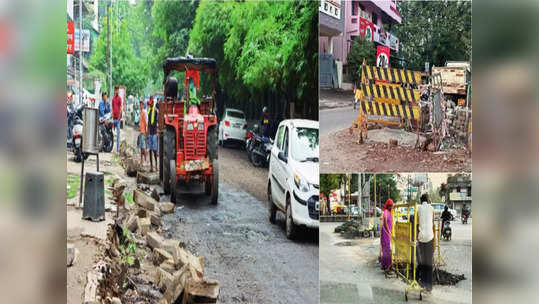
[219,109,247,147]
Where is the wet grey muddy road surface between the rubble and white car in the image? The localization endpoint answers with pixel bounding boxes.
[162,147,319,303]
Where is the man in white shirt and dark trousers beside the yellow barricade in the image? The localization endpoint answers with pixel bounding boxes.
[417,194,434,291]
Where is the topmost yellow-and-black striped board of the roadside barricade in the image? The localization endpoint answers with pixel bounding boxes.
[361,64,421,86]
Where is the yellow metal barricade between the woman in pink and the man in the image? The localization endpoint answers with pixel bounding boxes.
[392,203,423,301]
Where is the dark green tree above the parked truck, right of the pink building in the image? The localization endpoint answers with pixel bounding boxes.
[394,1,472,70]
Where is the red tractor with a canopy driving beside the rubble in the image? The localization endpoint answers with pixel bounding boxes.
[158,57,219,204]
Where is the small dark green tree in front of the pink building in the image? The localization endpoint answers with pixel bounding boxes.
[346,36,376,83]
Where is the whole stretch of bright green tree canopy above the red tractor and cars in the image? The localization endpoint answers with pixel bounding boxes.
[86,1,318,119]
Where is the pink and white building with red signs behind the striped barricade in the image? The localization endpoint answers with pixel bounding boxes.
[319,0,402,87]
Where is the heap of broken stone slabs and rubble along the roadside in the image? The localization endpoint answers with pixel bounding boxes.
[89,165,220,304]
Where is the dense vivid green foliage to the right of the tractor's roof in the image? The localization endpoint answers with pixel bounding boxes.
[189,1,318,119]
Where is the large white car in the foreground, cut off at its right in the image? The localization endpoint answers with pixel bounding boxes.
[268,119,320,239]
